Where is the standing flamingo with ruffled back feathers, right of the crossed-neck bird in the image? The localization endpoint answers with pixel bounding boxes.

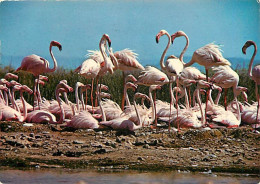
[111,48,144,110]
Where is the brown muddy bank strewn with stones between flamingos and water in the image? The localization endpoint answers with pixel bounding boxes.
[0,122,260,174]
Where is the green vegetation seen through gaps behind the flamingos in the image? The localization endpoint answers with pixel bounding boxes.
[0,66,255,104]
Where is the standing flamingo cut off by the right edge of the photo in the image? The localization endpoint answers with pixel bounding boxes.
[242,40,260,122]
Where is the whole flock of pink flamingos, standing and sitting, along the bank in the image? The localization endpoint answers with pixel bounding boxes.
[0,30,260,131]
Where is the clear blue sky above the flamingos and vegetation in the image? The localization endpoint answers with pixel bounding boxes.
[0,0,260,68]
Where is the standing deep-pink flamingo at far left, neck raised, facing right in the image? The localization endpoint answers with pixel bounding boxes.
[15,41,62,110]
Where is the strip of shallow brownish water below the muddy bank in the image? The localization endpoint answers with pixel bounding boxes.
[0,170,260,184]
